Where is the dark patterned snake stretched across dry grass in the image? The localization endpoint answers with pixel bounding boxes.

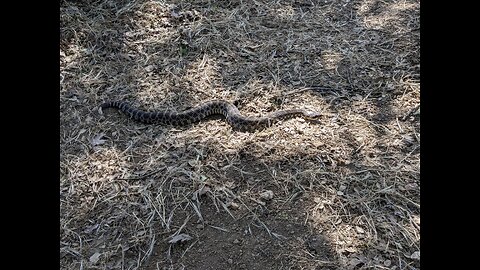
[100,100,320,132]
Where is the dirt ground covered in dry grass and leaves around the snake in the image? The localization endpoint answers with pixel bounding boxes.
[60,0,420,270]
